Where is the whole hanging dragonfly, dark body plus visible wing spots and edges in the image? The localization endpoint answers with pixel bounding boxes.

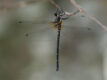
[18,9,90,71]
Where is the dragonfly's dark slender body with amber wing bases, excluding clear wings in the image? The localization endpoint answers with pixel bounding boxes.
[50,9,68,71]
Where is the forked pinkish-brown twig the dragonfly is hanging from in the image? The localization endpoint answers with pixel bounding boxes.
[49,0,107,31]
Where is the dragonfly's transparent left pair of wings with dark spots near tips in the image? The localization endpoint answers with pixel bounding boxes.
[17,21,70,37]
